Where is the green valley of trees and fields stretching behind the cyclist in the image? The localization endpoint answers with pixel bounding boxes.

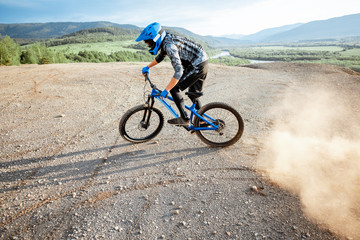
[0,28,360,72]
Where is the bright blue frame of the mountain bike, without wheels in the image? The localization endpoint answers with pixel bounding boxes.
[149,87,219,131]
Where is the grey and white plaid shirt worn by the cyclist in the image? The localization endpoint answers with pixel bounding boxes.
[155,34,209,79]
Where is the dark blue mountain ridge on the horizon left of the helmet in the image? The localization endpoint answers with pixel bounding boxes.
[0,22,141,39]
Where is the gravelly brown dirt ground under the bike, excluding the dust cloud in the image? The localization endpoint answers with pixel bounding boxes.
[0,63,360,239]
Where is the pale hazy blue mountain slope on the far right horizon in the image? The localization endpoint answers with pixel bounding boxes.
[262,14,360,42]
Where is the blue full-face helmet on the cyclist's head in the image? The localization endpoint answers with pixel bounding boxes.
[136,22,166,55]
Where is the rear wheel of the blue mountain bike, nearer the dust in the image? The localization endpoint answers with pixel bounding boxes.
[194,102,244,147]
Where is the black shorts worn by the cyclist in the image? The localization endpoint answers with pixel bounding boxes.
[179,61,209,92]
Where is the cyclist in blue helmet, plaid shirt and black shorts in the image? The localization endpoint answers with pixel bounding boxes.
[136,22,209,126]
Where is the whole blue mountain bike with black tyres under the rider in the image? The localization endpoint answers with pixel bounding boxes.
[119,75,244,147]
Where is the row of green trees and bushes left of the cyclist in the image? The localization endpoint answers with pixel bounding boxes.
[0,36,152,66]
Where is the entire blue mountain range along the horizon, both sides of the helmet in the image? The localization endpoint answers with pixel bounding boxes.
[0,14,360,48]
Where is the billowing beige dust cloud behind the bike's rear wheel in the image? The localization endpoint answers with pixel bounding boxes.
[259,87,360,239]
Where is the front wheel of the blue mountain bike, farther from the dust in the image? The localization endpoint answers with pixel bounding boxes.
[119,105,164,143]
